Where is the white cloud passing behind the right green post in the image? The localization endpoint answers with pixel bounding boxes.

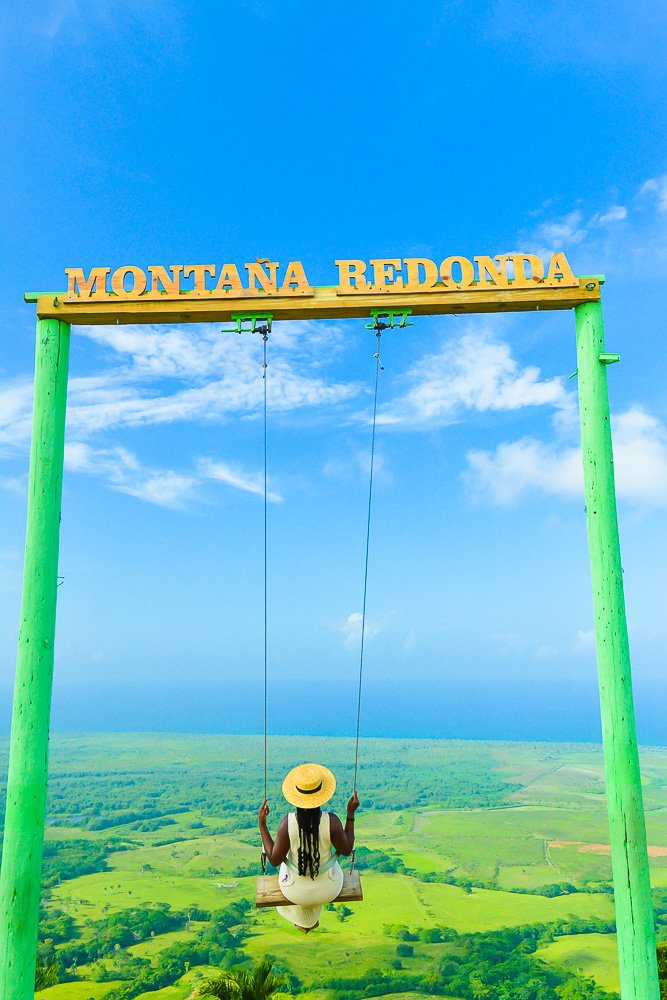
[466,407,667,507]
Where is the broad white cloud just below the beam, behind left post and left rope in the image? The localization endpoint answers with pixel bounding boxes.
[0,323,360,458]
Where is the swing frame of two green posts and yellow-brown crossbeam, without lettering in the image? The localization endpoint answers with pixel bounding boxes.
[0,276,659,1000]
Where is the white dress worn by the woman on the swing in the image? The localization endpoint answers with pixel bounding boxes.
[277,812,343,927]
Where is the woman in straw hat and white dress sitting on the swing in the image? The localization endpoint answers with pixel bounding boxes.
[258,764,359,934]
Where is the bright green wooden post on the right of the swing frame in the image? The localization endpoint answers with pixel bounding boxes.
[575,302,659,1000]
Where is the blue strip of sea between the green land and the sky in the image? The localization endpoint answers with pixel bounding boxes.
[0,678,667,746]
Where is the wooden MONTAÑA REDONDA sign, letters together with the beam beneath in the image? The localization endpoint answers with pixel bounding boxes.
[31,253,600,324]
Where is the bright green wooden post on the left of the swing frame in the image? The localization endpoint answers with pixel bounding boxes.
[0,319,70,1000]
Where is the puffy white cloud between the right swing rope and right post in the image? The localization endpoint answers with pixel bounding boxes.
[378,325,567,427]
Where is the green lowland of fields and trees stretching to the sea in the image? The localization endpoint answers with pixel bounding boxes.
[0,734,667,1000]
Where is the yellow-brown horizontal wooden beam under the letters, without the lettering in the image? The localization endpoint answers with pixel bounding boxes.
[28,276,601,326]
